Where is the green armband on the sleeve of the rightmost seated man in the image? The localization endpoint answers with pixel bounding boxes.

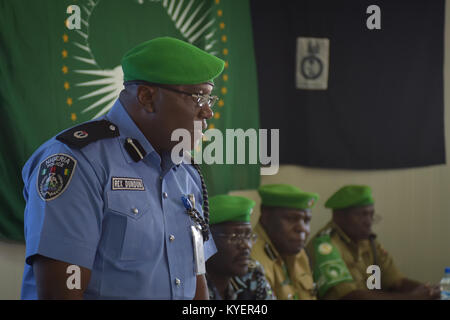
[313,234,353,297]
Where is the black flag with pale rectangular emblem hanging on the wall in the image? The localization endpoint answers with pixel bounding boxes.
[251,0,445,169]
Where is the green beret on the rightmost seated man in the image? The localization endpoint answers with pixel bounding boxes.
[325,186,374,209]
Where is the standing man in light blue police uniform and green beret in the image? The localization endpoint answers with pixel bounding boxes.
[22,37,224,299]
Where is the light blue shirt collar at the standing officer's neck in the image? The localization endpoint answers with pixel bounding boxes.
[106,99,156,162]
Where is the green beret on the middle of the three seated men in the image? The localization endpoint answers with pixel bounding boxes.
[258,184,319,209]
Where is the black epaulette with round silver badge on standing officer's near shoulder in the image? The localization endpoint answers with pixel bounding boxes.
[56,120,120,149]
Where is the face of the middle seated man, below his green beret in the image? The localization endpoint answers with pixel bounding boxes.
[260,206,311,256]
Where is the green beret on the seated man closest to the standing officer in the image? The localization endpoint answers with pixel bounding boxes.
[209,194,255,224]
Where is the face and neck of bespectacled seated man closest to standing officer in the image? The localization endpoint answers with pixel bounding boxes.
[206,222,252,298]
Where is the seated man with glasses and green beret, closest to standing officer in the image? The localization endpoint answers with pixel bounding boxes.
[206,195,274,300]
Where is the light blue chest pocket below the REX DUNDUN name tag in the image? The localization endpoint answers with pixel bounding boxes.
[107,191,154,260]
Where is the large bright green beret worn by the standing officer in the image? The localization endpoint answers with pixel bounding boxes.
[122,37,225,85]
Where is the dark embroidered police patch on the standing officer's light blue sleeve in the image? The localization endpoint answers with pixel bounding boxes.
[36,153,77,201]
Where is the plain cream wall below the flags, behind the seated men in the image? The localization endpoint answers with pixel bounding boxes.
[0,1,450,299]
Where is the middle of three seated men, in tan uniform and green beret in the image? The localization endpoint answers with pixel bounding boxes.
[252,184,319,300]
